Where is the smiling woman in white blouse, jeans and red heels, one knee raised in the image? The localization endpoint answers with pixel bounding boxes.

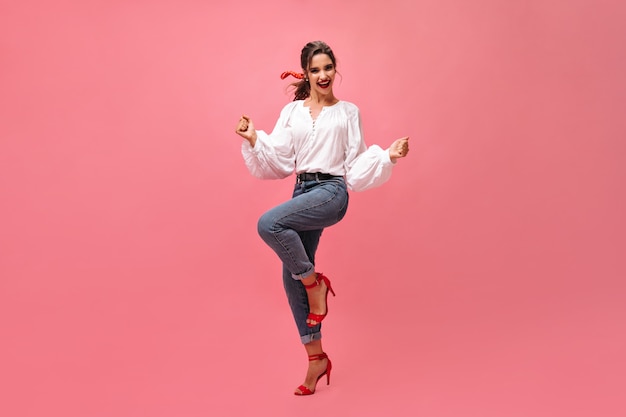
[236,41,409,395]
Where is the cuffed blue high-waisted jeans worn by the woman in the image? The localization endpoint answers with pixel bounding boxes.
[258,177,348,343]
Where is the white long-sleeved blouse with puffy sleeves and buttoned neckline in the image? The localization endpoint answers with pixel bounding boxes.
[241,100,394,191]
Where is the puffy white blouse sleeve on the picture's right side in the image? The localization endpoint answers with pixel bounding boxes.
[345,107,394,191]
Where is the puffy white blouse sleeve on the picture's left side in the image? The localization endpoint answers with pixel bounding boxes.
[241,103,295,179]
